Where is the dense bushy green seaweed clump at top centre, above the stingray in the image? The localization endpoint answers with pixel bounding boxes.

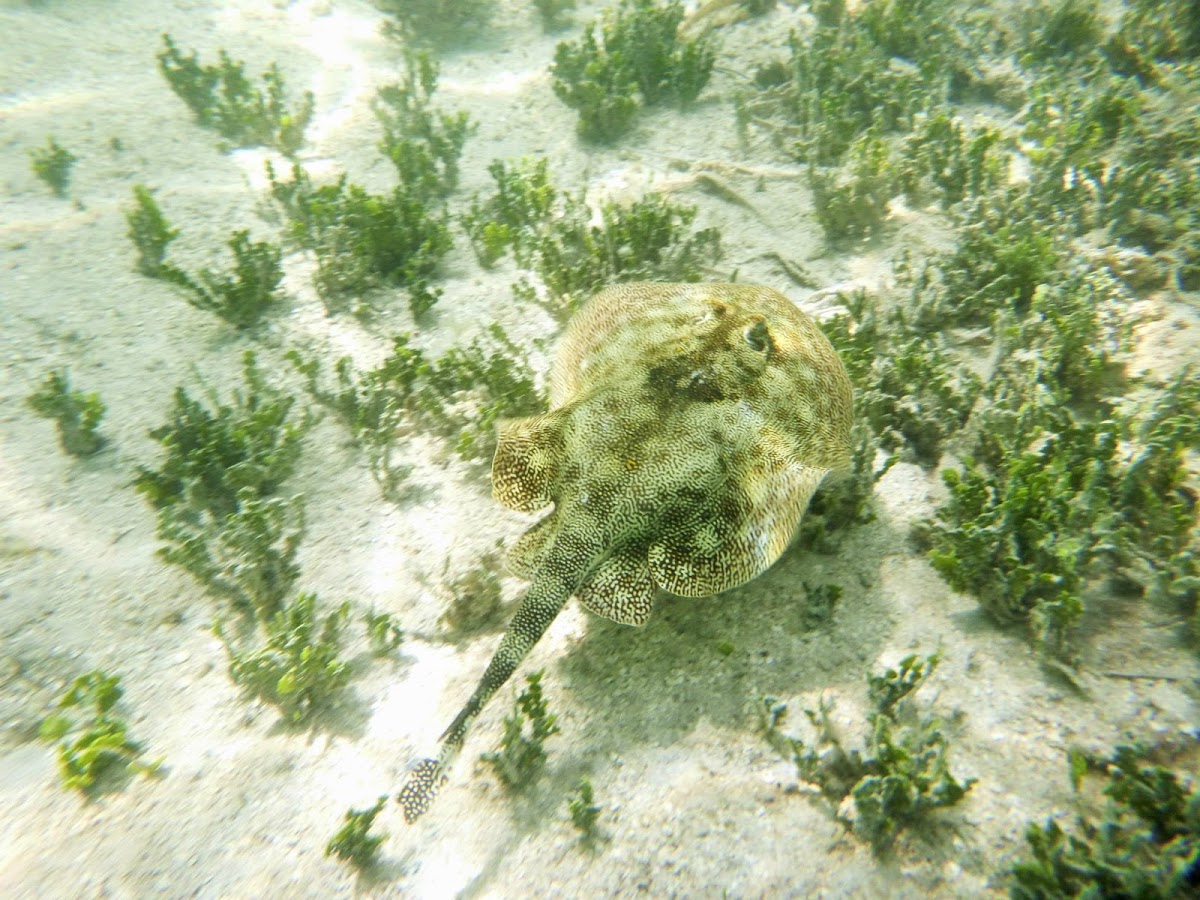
[550,0,716,143]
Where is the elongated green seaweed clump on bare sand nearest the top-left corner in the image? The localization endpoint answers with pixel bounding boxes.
[158,34,316,156]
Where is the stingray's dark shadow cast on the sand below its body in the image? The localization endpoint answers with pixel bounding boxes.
[552,526,890,758]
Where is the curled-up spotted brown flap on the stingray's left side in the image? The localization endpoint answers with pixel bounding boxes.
[492,413,565,512]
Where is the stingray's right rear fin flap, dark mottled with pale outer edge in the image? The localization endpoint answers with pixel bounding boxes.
[648,464,827,596]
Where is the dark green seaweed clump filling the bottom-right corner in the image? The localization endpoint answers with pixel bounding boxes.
[1008,745,1200,900]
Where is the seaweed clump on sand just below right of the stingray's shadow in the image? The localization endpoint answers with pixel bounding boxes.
[762,653,976,853]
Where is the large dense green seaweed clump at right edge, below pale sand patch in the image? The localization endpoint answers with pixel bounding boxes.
[929,362,1200,661]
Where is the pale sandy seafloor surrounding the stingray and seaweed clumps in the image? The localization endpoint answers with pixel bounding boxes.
[0,0,1200,898]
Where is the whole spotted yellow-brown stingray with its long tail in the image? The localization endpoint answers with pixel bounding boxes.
[397,283,852,822]
